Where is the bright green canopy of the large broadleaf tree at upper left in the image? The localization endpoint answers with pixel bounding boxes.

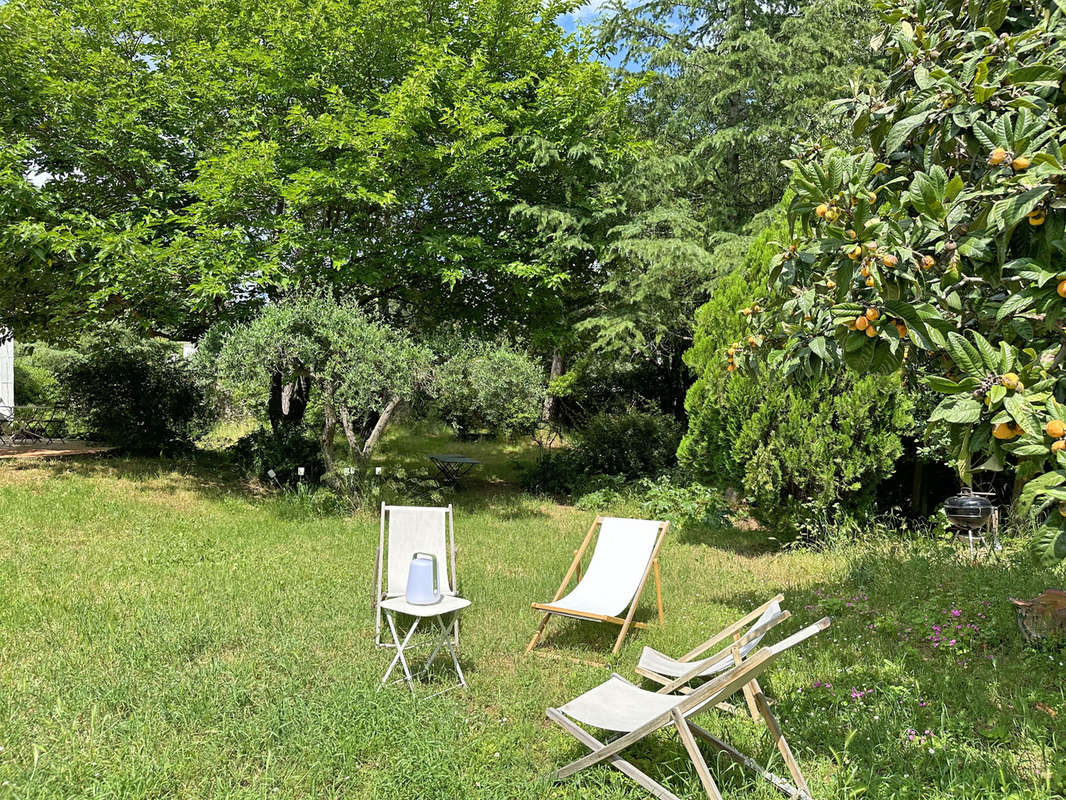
[0,0,640,338]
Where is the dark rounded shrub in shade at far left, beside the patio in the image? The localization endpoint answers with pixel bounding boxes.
[59,324,204,454]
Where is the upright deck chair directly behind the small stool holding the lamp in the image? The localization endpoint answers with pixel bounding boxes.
[374,502,459,647]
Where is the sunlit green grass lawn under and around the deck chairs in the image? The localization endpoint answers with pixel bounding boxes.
[0,431,1066,800]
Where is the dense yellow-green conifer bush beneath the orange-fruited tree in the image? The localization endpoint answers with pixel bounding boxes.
[679,208,915,531]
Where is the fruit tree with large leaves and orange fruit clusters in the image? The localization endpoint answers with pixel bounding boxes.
[741,0,1066,559]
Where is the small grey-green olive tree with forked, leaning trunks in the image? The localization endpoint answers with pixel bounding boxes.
[217,295,429,469]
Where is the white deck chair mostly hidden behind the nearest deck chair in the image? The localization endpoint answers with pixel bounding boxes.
[636,594,791,721]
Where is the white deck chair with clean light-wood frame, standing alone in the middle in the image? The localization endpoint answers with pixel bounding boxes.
[526,516,669,653]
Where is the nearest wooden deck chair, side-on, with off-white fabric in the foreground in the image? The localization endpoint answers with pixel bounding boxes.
[547,617,829,800]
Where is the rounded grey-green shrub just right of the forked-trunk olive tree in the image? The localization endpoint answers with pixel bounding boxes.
[430,336,546,435]
